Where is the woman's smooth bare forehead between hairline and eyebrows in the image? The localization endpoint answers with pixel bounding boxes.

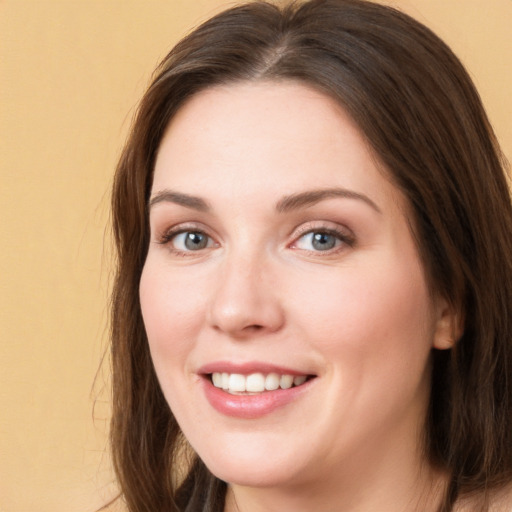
[153,81,401,214]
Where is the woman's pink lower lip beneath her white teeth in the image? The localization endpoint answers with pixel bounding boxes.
[203,378,315,419]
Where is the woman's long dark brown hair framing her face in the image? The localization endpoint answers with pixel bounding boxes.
[111,0,512,512]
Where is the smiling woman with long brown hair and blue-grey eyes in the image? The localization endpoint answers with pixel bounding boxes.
[108,0,512,512]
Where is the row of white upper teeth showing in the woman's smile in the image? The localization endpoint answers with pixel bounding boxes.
[212,372,307,394]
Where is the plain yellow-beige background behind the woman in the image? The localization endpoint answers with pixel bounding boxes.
[0,0,512,512]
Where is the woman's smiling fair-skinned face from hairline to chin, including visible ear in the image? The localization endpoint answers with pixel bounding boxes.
[140,82,449,486]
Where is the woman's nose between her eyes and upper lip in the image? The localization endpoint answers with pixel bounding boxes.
[209,251,285,338]
